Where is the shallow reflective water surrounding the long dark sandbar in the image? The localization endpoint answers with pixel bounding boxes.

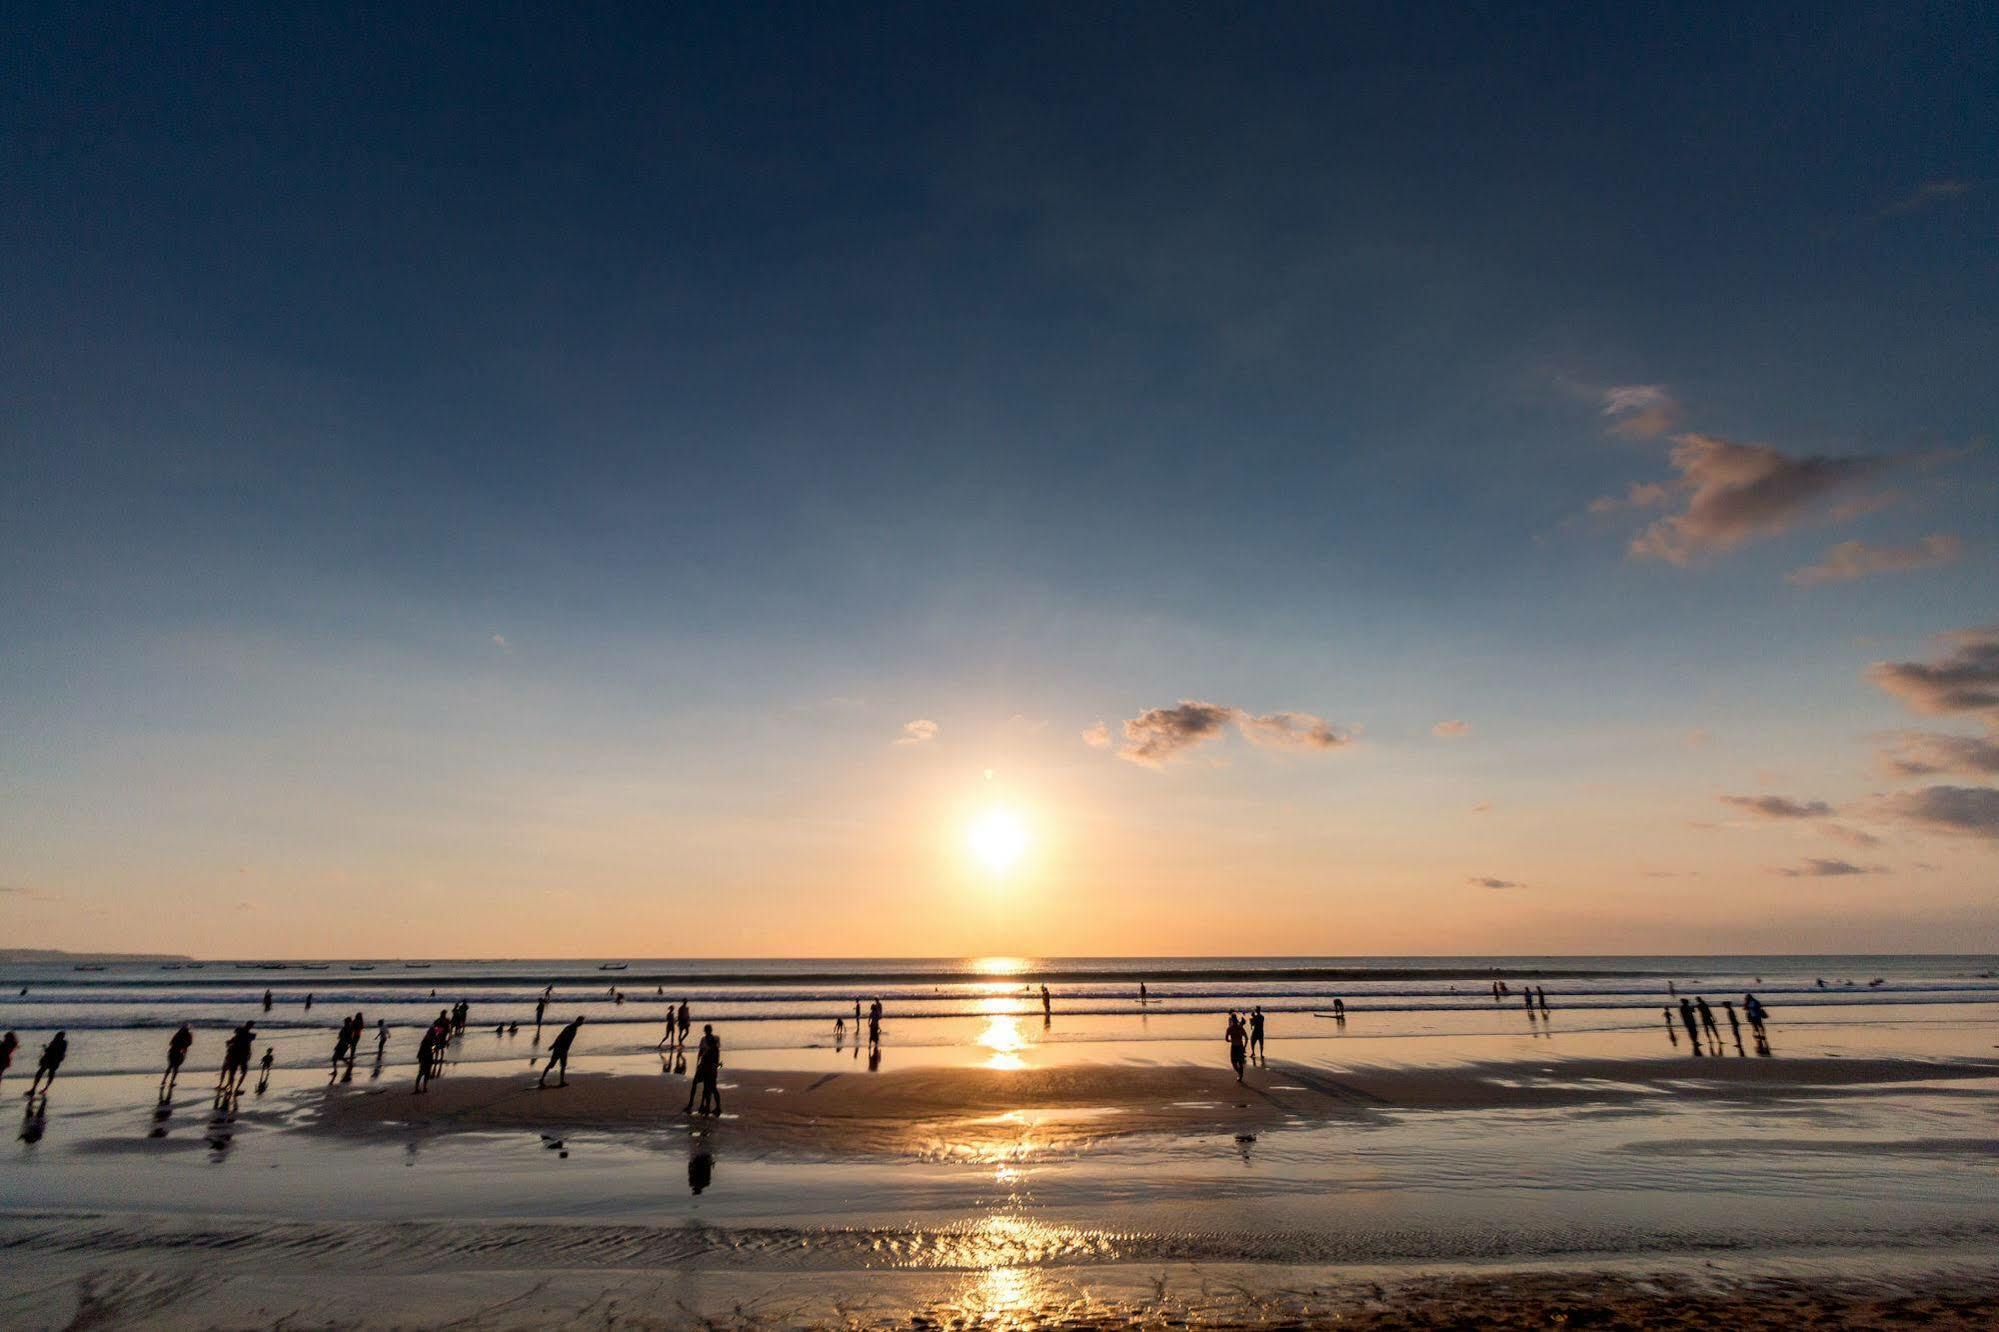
[0,964,1999,1326]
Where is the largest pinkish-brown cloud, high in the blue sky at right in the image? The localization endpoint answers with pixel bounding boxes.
[1631,434,1883,564]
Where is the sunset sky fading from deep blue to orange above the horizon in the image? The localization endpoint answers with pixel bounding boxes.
[0,4,1999,956]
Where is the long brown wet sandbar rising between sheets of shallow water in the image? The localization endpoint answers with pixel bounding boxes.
[295,1058,1999,1156]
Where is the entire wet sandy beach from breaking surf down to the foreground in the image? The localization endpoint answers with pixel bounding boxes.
[0,966,1999,1328]
